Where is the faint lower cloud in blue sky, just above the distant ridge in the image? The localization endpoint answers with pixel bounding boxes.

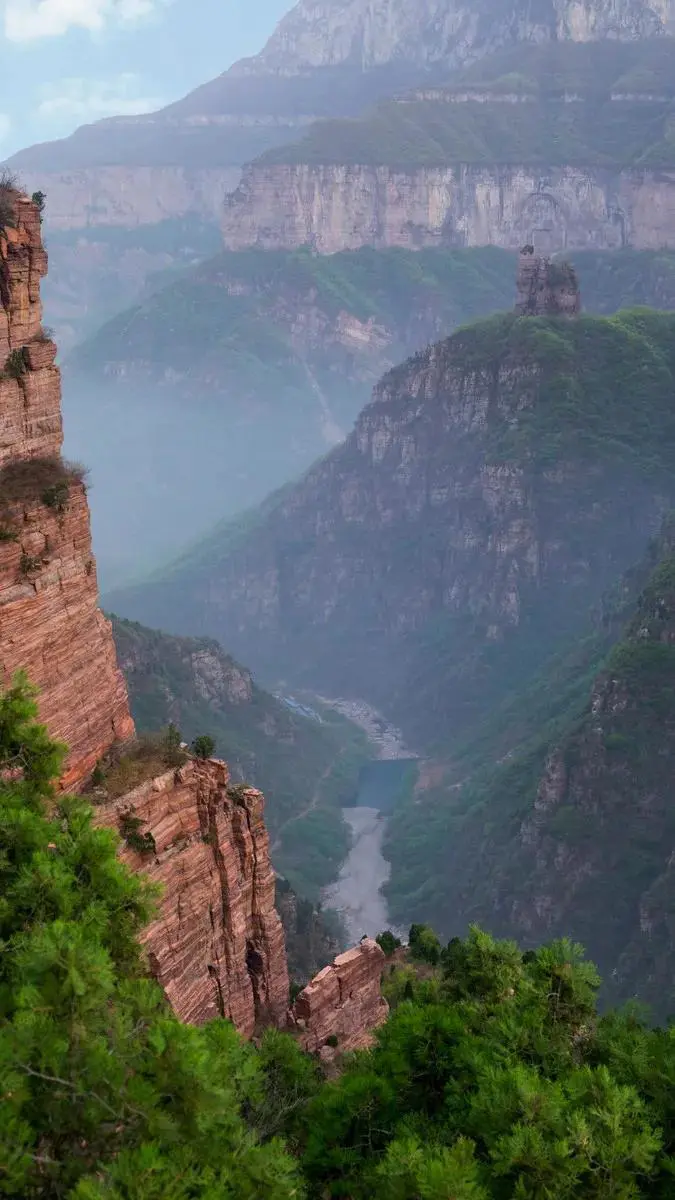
[37,72,165,124]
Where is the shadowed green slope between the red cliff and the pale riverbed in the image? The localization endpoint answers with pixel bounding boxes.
[113,617,370,900]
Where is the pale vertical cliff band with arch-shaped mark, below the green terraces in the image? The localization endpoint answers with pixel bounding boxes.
[223,160,675,254]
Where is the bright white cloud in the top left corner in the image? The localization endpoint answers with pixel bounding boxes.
[0,0,169,42]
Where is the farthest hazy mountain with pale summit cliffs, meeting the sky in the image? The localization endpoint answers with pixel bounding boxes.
[10,0,673,346]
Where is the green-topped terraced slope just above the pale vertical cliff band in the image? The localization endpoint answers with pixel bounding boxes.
[262,40,675,169]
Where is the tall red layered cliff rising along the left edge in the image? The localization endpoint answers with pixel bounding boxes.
[0,192,133,788]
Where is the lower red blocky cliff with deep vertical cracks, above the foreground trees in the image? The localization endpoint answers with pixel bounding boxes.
[97,760,288,1037]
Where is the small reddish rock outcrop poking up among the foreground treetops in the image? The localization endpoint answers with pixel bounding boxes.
[291,937,389,1054]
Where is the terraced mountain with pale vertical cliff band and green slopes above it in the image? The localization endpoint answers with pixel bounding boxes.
[223,38,675,254]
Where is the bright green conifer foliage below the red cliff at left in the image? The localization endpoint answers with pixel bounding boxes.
[0,677,301,1200]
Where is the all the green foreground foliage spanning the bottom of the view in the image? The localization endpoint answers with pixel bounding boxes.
[0,677,675,1200]
